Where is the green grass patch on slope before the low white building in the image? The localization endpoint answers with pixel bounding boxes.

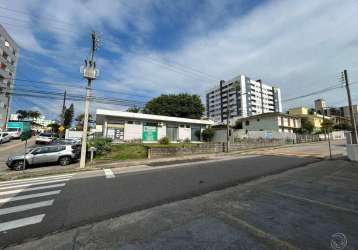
[97,144,147,160]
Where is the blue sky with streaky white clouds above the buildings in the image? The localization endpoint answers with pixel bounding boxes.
[0,0,358,119]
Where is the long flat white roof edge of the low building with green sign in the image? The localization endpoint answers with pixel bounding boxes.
[96,109,214,125]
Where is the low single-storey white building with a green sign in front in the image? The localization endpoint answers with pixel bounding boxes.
[96,109,214,143]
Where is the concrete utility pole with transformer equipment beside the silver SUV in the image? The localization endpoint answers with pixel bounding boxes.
[80,32,98,168]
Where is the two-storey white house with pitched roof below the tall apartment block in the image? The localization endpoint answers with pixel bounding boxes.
[236,112,301,133]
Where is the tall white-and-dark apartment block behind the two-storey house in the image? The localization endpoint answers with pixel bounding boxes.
[206,75,282,122]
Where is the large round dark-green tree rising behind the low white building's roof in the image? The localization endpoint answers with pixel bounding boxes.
[143,93,205,119]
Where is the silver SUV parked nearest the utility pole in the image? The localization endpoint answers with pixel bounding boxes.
[6,145,80,170]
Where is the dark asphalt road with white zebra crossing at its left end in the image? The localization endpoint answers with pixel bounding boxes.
[0,156,317,247]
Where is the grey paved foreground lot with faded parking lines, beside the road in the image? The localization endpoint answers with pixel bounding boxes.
[8,160,358,249]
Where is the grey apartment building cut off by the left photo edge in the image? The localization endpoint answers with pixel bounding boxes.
[0,24,19,129]
